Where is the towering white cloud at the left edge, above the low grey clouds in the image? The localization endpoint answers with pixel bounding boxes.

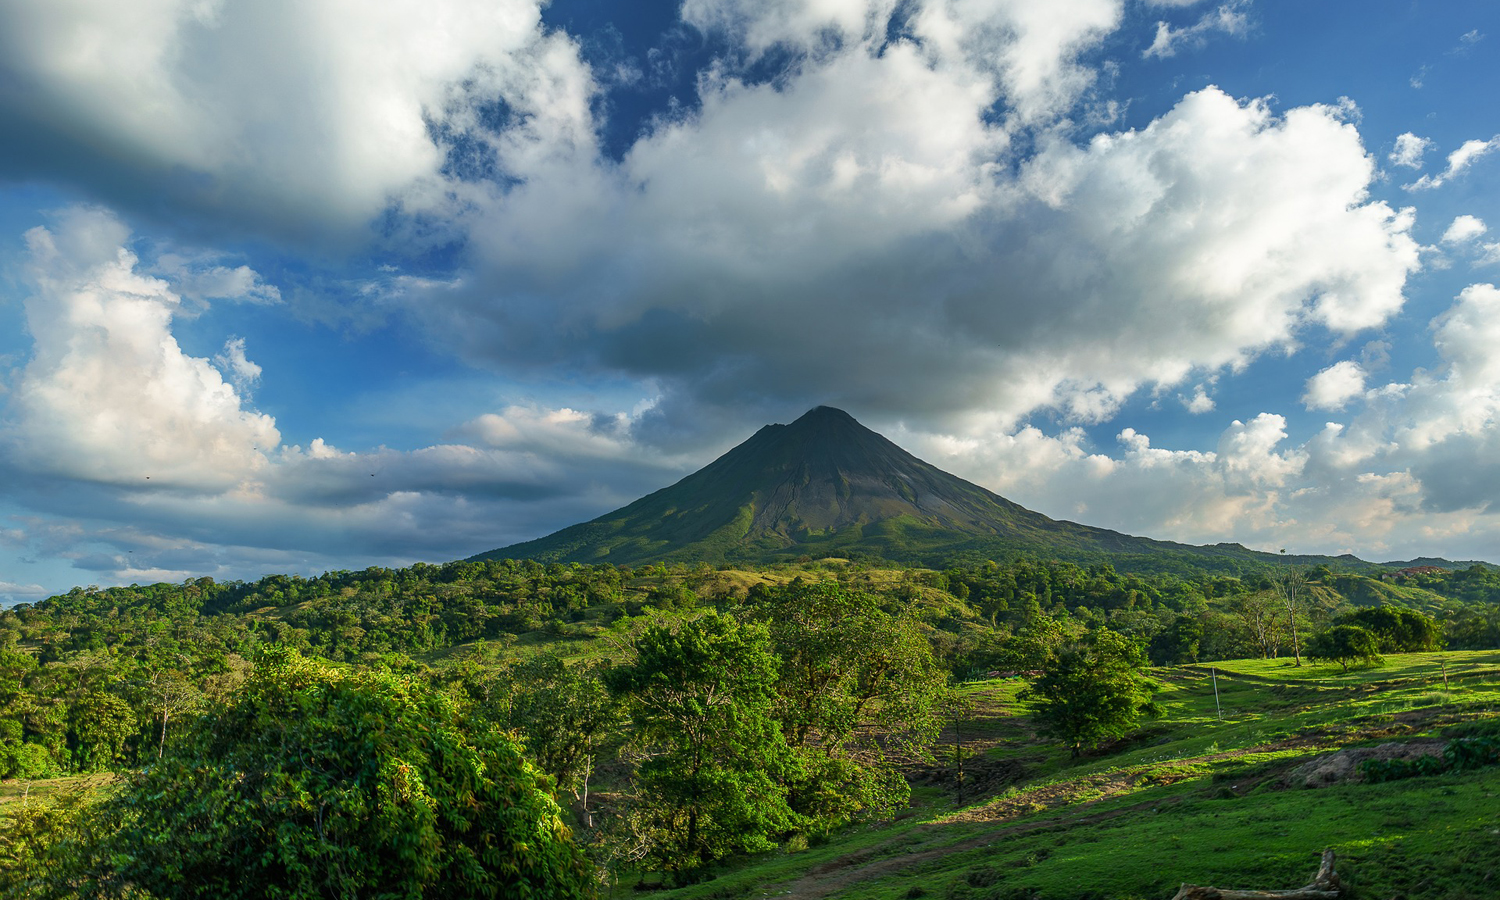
[12,209,281,488]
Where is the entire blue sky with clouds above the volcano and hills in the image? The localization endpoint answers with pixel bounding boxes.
[0,0,1500,602]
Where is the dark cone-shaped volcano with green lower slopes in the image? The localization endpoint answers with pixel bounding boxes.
[474,407,1260,564]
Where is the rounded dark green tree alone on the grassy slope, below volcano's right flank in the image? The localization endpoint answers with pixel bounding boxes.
[1020,629,1158,758]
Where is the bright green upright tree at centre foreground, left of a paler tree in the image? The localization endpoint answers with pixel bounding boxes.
[605,612,795,881]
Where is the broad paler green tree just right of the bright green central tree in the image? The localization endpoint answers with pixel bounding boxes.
[752,579,948,827]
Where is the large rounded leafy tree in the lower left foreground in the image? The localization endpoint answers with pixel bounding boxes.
[49,648,591,900]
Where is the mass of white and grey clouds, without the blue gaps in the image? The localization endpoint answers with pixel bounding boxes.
[0,0,1500,591]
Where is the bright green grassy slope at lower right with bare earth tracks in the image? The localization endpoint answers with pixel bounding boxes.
[651,651,1500,900]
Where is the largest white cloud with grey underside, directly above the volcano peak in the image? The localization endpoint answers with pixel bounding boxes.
[423,79,1419,438]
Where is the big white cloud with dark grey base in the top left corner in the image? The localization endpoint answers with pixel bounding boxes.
[0,0,591,240]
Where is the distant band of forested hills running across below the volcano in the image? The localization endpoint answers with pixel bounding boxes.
[0,558,1500,779]
